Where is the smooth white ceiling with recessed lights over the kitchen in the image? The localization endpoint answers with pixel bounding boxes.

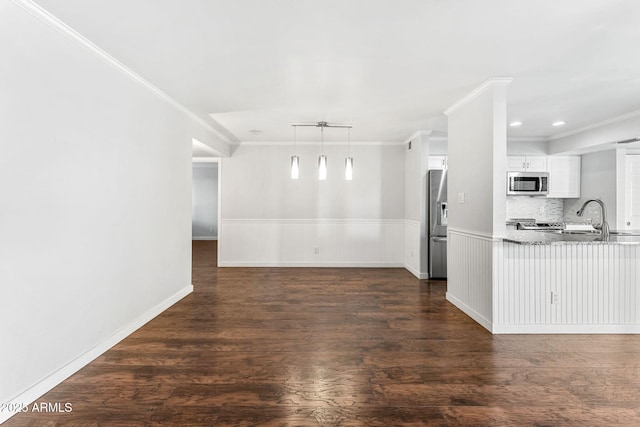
[36,0,640,143]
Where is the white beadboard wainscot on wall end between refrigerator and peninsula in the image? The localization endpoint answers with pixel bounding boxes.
[447,227,494,330]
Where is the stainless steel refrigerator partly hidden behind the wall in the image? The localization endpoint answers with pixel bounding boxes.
[427,169,448,279]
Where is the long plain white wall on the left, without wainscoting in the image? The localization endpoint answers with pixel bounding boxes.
[0,2,218,421]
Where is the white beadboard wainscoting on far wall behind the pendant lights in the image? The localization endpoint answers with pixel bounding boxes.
[218,219,405,267]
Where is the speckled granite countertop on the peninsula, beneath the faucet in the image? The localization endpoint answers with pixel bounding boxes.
[503,230,640,245]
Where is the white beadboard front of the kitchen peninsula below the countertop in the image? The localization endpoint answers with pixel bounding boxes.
[494,243,640,333]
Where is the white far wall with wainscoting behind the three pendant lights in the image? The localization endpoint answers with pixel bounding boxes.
[219,144,405,266]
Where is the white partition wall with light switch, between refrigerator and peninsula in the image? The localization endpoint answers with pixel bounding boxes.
[445,79,508,330]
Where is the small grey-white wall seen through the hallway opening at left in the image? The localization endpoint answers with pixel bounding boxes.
[191,162,218,240]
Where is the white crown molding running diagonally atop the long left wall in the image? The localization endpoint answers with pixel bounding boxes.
[12,0,233,144]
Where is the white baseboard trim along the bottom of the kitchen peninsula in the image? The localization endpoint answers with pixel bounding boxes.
[493,324,640,334]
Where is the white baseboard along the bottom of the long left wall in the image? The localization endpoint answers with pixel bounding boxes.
[0,285,193,423]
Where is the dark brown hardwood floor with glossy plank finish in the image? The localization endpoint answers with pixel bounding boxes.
[6,241,640,426]
